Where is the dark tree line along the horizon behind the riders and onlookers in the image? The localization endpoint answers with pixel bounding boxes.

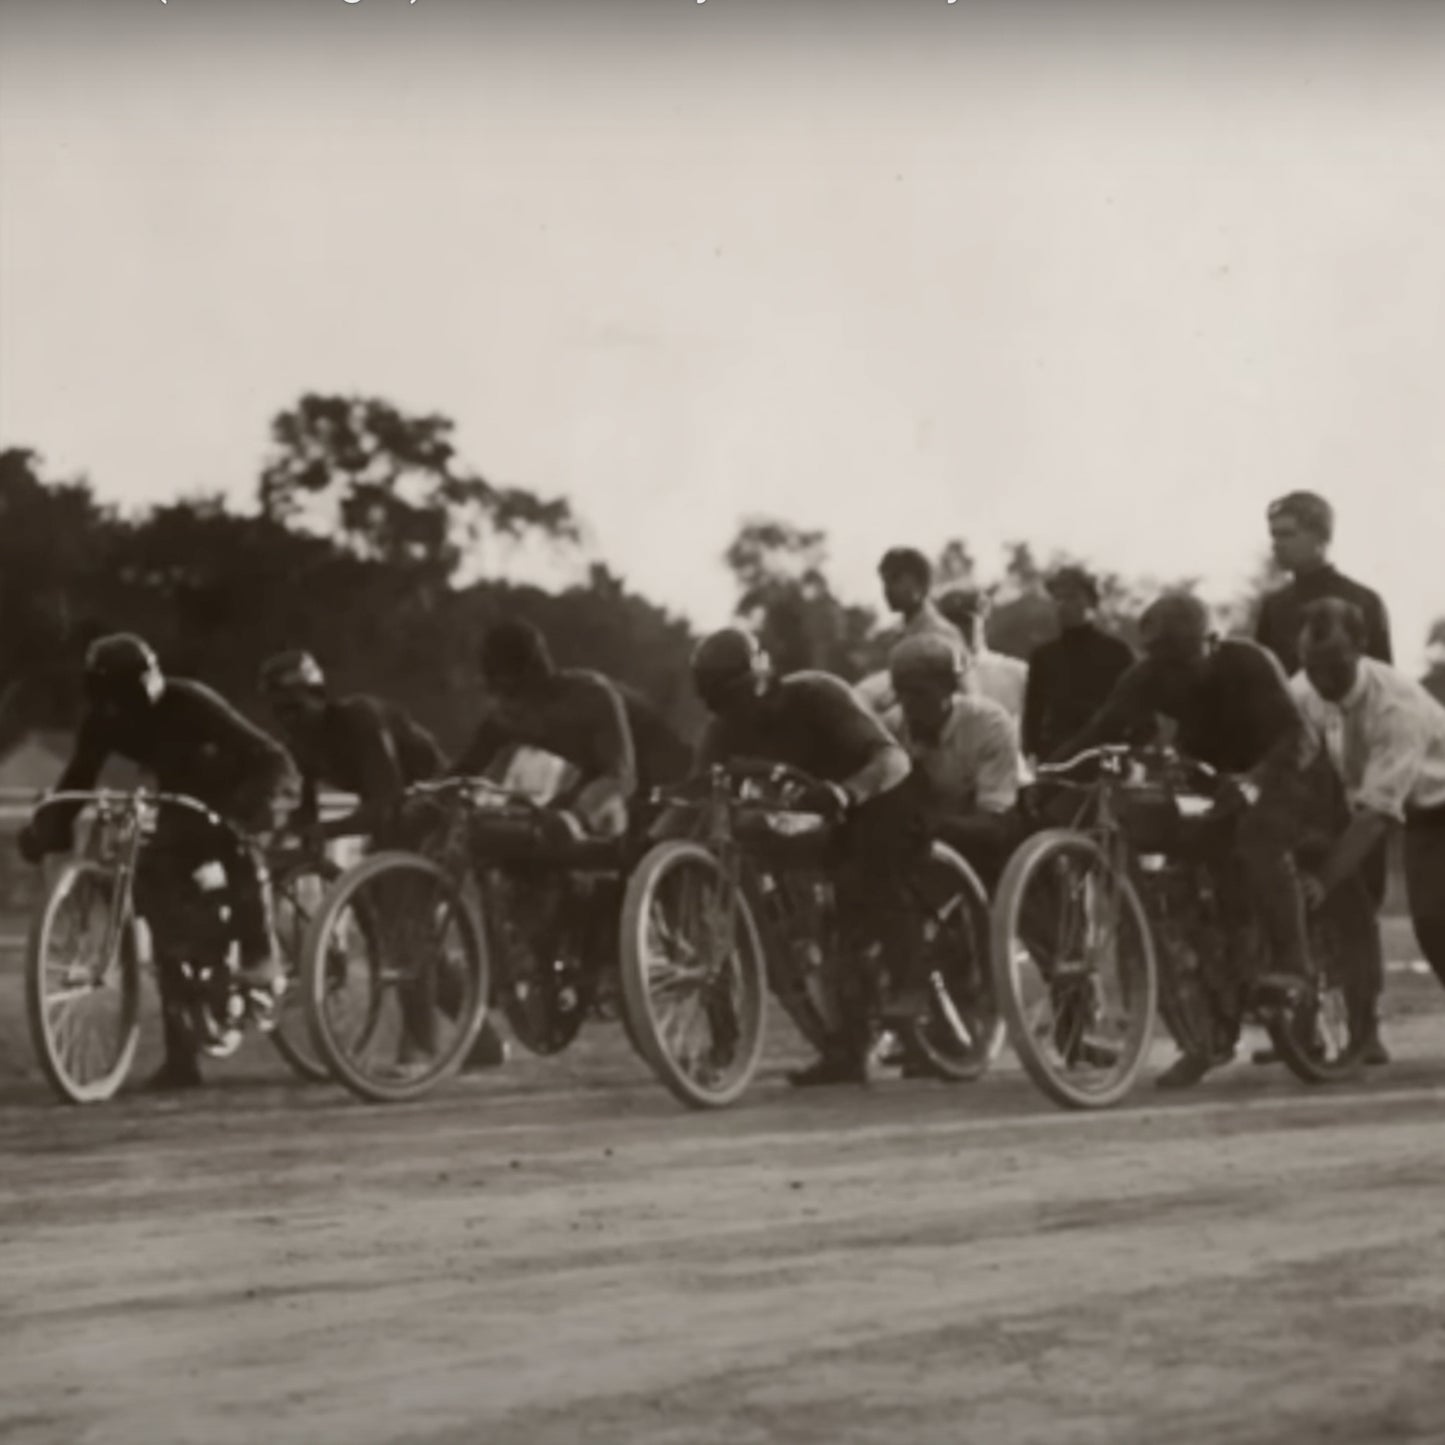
[0,394,1445,753]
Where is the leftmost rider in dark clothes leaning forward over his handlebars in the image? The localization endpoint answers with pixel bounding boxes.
[19,633,301,1088]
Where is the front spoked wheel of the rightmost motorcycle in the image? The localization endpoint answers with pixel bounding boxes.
[990,828,1159,1108]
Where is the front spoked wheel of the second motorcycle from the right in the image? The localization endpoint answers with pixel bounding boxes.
[620,841,767,1108]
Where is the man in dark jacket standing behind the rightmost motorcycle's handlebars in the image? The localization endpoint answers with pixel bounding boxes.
[1023,566,1134,759]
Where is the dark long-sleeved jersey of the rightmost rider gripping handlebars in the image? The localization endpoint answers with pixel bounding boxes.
[1056,637,1306,773]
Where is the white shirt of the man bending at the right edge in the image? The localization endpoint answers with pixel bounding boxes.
[1289,657,1445,819]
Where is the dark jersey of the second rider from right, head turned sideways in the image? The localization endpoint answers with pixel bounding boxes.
[698,672,899,783]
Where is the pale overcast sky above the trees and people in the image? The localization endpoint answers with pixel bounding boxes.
[0,0,1445,663]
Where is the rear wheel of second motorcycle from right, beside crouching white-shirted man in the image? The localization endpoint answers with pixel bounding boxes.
[913,842,1006,1082]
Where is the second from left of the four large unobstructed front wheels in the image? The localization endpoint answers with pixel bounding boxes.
[302,853,491,1104]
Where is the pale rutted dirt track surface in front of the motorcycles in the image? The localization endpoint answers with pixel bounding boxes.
[0,1016,1445,1445]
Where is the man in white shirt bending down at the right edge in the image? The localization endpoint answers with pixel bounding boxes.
[1290,598,1445,1005]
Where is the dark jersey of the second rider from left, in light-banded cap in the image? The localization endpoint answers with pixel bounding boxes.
[292,694,447,818]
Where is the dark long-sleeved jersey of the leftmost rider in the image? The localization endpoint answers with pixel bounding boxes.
[56,678,295,815]
